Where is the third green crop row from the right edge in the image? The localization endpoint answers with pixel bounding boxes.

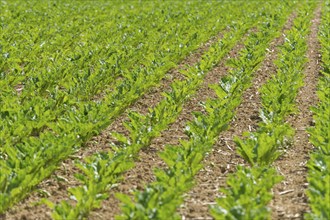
[117,3,296,219]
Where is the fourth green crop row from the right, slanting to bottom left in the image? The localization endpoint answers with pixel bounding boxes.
[45,2,268,219]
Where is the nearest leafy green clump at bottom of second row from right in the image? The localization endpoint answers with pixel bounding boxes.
[211,166,283,219]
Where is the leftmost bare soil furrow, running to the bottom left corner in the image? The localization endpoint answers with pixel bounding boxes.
[5,30,228,219]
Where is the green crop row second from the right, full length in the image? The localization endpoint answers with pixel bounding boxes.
[211,3,316,219]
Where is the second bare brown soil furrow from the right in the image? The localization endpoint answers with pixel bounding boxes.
[180,14,295,219]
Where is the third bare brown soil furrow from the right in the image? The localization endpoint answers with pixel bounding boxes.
[87,29,250,219]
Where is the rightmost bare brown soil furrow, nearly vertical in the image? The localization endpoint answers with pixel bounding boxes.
[270,7,321,219]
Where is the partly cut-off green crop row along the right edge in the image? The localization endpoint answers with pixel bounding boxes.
[305,1,330,219]
